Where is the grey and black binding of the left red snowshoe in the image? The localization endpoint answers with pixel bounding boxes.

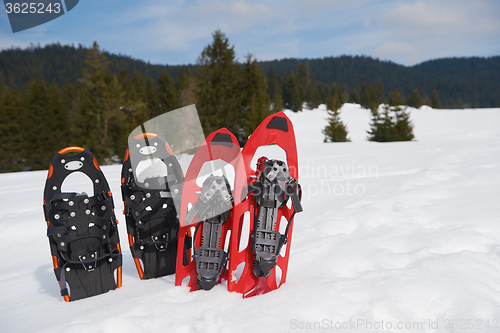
[185,175,233,290]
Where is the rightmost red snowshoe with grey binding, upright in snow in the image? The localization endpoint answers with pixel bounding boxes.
[228,112,302,297]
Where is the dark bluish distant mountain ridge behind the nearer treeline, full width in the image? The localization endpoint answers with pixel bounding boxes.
[0,44,500,107]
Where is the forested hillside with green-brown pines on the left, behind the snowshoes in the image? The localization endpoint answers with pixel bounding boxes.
[0,31,271,172]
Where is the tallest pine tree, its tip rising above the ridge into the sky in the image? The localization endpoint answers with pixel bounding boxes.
[196,30,243,136]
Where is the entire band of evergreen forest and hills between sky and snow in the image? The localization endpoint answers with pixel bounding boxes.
[0,31,500,172]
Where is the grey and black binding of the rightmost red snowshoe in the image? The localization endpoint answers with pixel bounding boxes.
[248,157,302,277]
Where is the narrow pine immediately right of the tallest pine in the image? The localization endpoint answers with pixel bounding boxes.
[240,54,270,140]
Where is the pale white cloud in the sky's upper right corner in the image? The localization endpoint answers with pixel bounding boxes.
[373,0,500,64]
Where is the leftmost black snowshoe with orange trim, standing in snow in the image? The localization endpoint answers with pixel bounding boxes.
[43,147,122,301]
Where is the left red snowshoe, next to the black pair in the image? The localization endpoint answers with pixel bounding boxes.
[175,128,246,291]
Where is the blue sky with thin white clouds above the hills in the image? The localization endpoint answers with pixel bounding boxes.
[0,0,500,66]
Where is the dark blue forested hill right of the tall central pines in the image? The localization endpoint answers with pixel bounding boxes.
[260,56,500,108]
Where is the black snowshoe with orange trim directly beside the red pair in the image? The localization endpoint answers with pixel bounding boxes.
[121,133,184,279]
